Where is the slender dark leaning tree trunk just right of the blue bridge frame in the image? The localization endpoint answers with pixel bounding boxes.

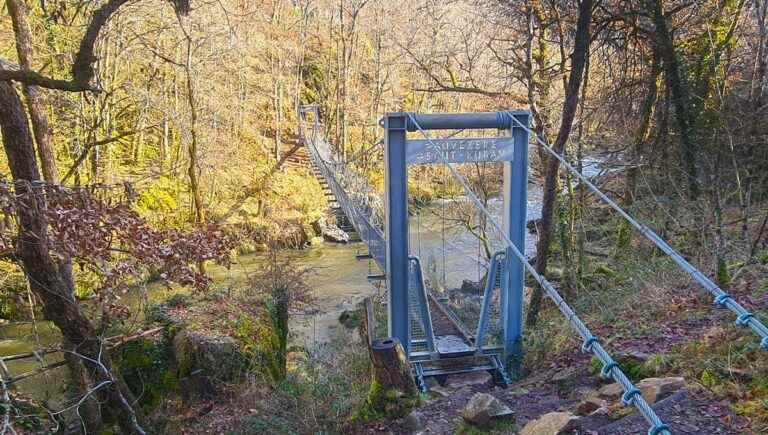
[526,0,593,327]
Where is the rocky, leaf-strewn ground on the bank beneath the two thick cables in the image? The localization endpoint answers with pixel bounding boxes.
[365,274,762,435]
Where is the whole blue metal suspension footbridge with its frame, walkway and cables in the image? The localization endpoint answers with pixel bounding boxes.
[299,106,768,435]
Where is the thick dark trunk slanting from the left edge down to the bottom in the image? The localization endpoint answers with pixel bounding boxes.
[0,81,145,434]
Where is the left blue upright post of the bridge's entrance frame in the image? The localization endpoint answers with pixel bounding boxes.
[384,113,411,355]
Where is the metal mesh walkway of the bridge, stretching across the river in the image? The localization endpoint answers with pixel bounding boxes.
[299,107,510,391]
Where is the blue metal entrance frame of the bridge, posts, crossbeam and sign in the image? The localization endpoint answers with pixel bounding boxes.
[383,112,528,372]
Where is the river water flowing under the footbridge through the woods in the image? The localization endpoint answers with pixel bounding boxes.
[0,164,596,403]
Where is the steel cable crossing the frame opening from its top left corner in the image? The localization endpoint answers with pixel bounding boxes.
[408,113,671,435]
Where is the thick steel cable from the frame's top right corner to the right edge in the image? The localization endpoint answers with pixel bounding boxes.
[507,112,768,350]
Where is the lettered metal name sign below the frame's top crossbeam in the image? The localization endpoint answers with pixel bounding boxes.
[405,137,515,165]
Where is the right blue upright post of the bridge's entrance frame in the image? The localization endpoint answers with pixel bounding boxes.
[501,112,529,378]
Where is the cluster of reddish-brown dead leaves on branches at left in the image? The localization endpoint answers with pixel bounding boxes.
[0,184,234,291]
